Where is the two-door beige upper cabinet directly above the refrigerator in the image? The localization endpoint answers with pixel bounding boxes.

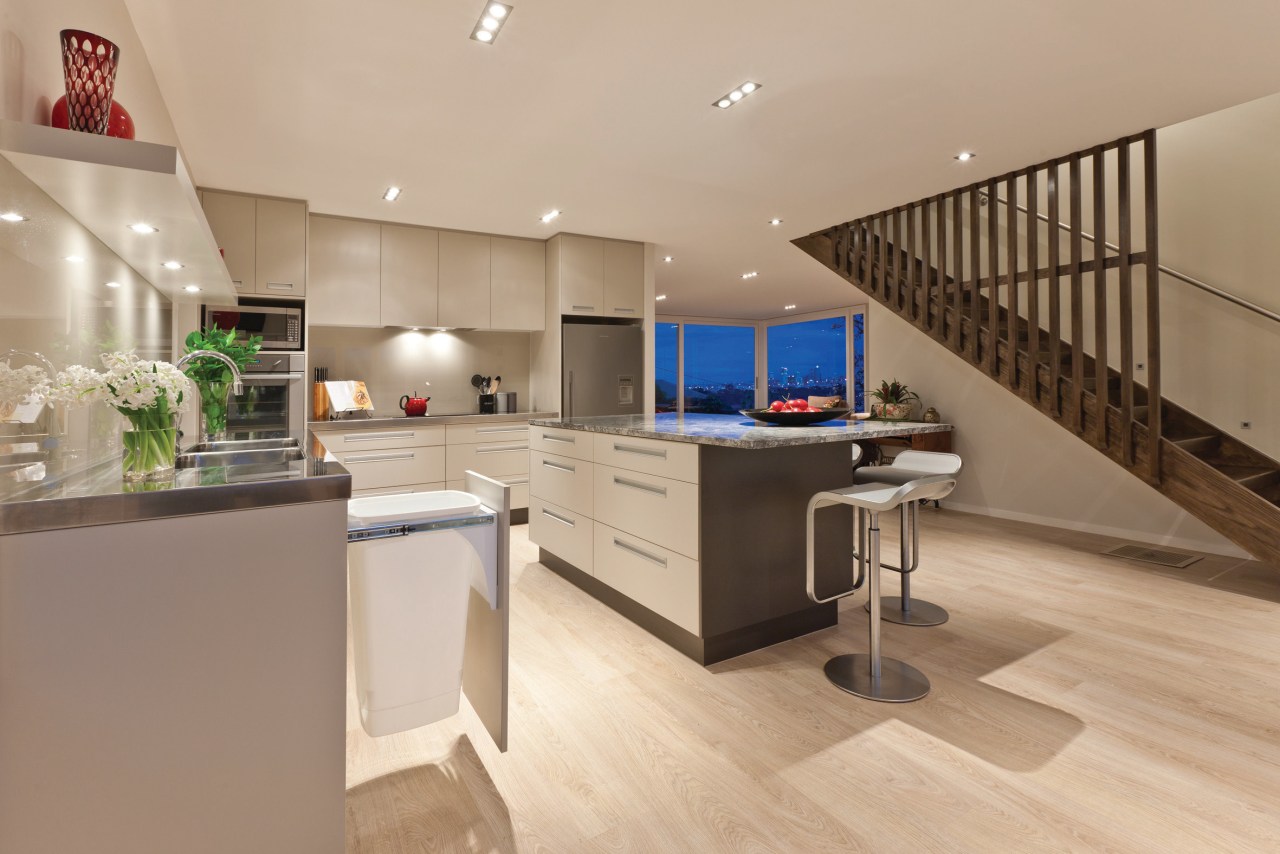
[548,234,644,318]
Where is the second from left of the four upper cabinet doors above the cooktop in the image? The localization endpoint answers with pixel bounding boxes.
[380,225,440,326]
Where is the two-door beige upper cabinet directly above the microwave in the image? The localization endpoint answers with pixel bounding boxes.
[201,189,307,297]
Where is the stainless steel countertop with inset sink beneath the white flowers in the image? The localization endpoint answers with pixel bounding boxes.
[0,435,351,535]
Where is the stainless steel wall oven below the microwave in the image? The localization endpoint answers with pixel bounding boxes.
[227,351,308,439]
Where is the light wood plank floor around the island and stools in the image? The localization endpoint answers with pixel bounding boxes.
[347,510,1280,854]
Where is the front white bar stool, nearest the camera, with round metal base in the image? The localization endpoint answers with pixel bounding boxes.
[805,475,956,703]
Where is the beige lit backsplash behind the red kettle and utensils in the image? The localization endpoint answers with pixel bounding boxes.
[306,326,530,416]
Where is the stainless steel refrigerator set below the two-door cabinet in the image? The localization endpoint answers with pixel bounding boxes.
[561,323,644,417]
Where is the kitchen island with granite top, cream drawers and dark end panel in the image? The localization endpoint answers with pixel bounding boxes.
[529,414,951,665]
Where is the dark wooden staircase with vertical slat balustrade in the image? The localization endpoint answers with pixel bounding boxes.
[794,131,1280,566]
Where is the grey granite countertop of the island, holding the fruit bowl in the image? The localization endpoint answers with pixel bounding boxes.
[530,412,952,448]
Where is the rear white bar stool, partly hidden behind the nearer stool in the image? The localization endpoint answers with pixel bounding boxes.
[854,451,964,626]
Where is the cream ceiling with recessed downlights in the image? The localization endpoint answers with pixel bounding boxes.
[127,0,1280,319]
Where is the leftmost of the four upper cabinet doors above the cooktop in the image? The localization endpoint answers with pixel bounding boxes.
[307,216,381,326]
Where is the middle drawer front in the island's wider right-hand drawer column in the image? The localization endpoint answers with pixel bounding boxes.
[596,463,698,561]
